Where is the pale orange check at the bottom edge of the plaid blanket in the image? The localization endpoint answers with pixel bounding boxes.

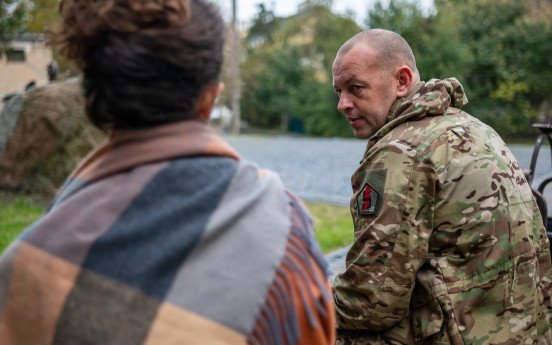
[145,303,247,345]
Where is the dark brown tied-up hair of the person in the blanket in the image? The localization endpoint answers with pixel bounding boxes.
[51,0,224,129]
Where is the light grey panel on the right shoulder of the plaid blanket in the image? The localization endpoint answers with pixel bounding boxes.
[167,162,291,334]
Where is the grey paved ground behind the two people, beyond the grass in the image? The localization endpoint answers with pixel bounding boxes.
[225,136,552,279]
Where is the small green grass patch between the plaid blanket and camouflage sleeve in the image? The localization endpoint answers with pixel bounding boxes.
[307,202,353,253]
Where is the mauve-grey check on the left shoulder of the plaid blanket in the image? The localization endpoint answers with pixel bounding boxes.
[24,163,167,266]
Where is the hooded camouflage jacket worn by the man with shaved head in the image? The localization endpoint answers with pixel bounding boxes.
[334,79,552,345]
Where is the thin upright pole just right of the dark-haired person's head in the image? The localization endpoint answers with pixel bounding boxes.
[231,0,241,134]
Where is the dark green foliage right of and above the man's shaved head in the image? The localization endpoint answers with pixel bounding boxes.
[366,0,552,137]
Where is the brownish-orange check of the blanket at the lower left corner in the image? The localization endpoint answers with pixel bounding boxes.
[0,243,79,345]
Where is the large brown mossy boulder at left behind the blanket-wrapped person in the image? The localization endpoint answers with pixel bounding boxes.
[0,78,105,194]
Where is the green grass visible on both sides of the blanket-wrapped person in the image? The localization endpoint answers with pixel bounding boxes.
[0,193,353,253]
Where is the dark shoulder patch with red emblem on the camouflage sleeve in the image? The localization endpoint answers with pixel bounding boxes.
[357,169,387,217]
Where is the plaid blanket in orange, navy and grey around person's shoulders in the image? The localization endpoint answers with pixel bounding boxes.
[0,121,334,345]
